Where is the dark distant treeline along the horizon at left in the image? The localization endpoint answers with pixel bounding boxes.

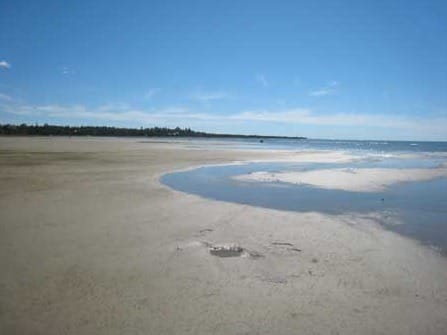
[0,123,305,139]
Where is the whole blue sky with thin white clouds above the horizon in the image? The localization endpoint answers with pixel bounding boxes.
[0,0,447,140]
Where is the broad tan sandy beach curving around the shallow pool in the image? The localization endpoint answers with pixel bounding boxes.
[0,138,447,335]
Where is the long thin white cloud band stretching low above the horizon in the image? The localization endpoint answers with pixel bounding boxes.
[3,104,447,129]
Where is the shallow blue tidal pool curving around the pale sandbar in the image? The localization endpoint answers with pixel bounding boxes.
[161,157,447,254]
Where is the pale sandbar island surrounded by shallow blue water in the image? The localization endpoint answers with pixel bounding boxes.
[234,167,447,192]
